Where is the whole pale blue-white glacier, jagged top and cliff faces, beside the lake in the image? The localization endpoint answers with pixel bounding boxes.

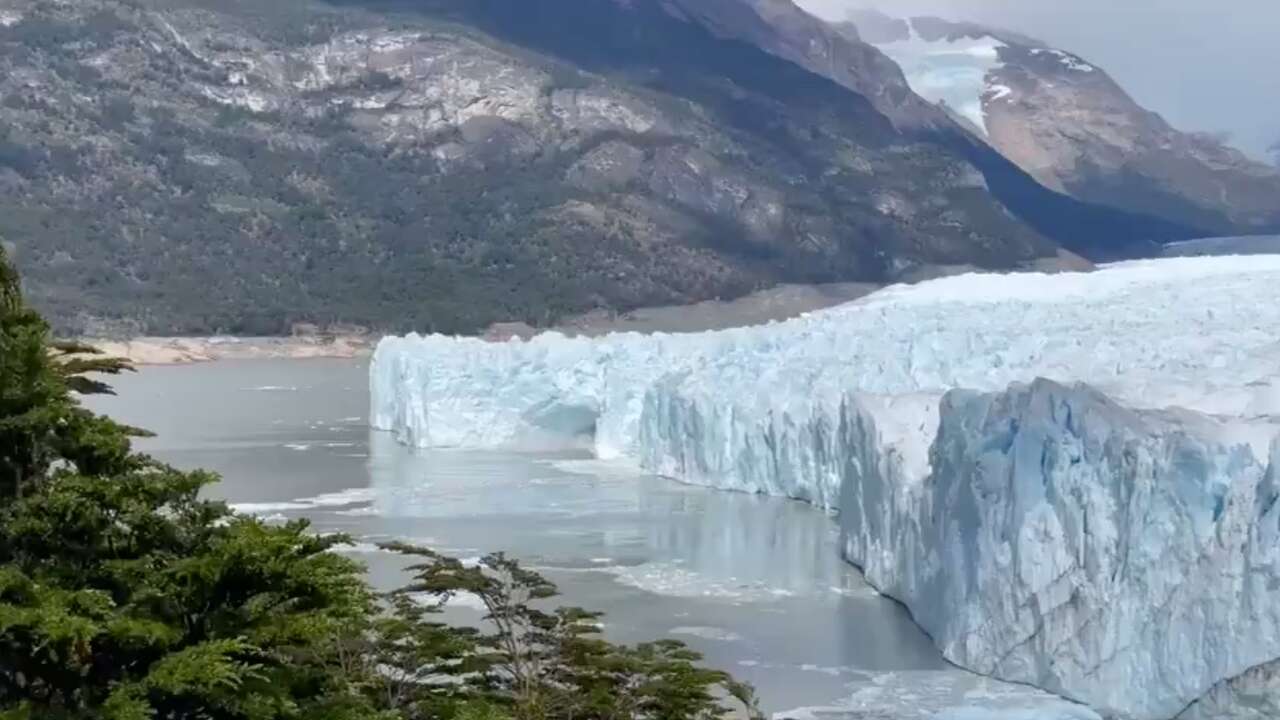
[371,256,1280,720]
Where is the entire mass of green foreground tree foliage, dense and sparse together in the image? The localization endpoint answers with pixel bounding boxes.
[0,242,756,720]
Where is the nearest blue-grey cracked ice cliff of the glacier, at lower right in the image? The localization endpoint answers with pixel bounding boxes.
[841,379,1280,719]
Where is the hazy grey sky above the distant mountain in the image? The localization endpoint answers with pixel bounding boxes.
[797,0,1280,158]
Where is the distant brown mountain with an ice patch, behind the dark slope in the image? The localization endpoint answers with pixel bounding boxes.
[845,10,1280,234]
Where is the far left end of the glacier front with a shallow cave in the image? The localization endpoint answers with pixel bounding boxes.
[370,325,755,459]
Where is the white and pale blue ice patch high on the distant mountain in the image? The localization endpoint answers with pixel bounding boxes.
[877,20,1006,132]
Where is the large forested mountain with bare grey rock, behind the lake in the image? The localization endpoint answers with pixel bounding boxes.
[0,0,1197,334]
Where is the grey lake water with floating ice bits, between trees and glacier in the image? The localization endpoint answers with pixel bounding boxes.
[82,360,1089,720]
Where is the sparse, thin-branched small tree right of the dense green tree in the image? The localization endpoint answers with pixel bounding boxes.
[384,543,759,720]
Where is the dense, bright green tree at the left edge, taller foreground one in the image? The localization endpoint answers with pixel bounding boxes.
[0,242,376,720]
